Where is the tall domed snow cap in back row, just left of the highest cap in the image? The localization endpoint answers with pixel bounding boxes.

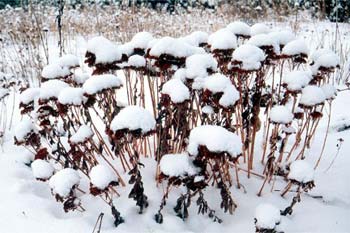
[208,29,237,51]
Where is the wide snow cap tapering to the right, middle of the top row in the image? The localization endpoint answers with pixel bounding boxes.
[150,37,204,58]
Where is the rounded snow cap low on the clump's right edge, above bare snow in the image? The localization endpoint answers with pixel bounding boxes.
[288,160,314,184]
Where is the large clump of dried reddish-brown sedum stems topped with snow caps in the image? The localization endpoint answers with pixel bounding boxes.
[15,22,339,232]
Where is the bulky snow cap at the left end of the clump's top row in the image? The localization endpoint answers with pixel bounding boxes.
[87,36,122,64]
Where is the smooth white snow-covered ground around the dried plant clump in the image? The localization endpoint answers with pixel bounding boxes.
[0,16,350,233]
